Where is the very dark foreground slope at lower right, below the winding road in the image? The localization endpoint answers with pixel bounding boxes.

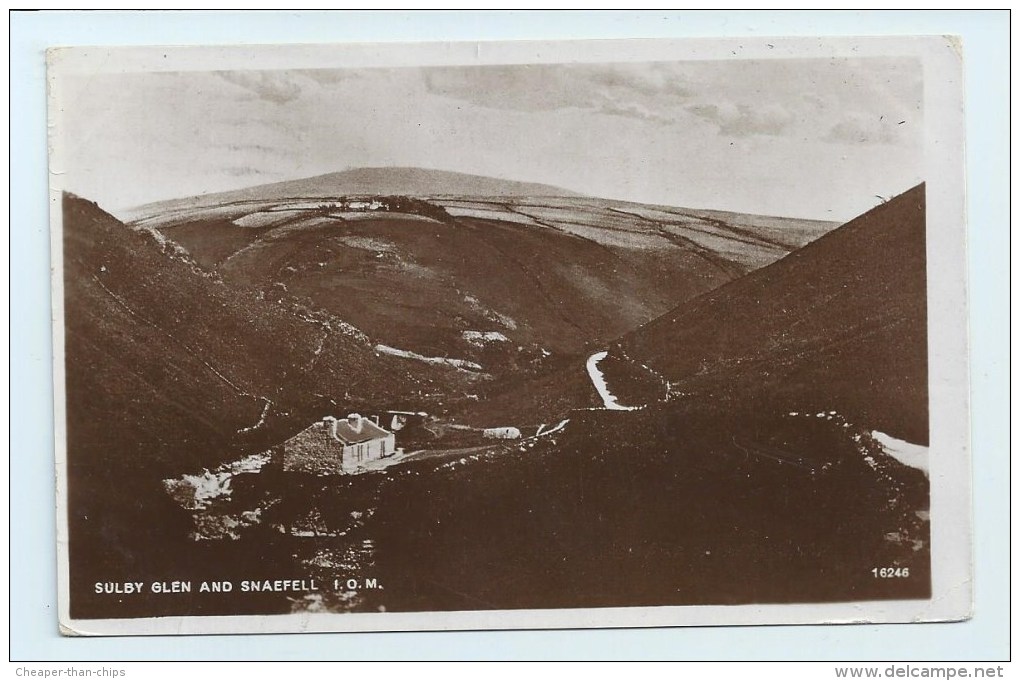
[359,405,929,611]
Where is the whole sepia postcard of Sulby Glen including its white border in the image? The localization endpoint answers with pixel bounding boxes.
[47,37,971,635]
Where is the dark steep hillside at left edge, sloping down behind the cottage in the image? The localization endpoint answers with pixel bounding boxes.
[63,195,456,615]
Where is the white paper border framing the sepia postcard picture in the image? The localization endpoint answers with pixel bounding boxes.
[49,37,973,635]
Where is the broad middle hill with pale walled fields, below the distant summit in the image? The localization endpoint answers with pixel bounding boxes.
[125,186,834,358]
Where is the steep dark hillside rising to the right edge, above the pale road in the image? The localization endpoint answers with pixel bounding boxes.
[611,185,928,443]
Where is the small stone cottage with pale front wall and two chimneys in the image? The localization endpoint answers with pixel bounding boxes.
[277,414,397,475]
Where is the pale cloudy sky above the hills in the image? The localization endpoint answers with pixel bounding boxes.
[53,57,924,220]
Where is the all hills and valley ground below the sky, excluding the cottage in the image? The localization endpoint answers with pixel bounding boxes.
[63,168,930,618]
